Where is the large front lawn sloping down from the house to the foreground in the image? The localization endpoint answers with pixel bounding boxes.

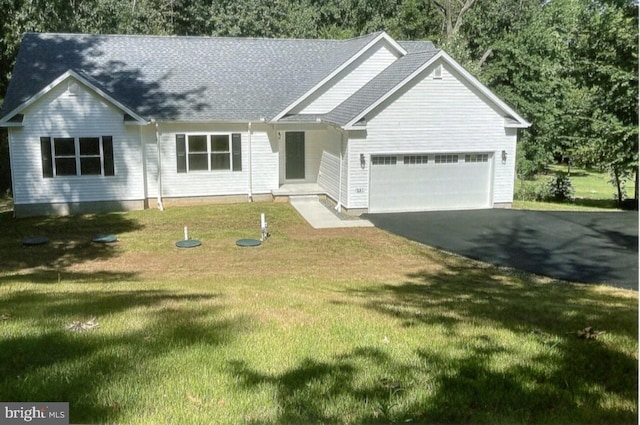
[0,203,638,424]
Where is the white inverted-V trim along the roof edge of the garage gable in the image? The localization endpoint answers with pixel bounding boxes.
[344,50,531,130]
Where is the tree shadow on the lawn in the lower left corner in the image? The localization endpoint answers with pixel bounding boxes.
[0,290,246,423]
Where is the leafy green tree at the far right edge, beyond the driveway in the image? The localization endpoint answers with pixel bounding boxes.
[569,0,638,204]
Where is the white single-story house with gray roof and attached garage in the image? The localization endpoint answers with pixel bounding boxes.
[0,32,530,216]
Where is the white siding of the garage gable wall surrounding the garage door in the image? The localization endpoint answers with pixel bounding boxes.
[347,59,516,209]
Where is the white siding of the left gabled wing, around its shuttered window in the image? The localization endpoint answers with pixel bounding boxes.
[10,81,144,205]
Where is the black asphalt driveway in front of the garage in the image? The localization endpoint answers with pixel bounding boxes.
[365,209,638,291]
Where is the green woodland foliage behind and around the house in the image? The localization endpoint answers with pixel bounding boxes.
[0,0,638,200]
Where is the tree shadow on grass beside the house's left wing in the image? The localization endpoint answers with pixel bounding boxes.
[0,213,142,272]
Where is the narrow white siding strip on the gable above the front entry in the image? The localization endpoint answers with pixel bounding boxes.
[293,40,397,114]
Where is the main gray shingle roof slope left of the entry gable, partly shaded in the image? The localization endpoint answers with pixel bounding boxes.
[0,33,379,121]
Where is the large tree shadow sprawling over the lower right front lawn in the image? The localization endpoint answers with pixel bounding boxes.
[229,262,638,424]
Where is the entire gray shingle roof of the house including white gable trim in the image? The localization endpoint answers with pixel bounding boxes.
[0,32,530,129]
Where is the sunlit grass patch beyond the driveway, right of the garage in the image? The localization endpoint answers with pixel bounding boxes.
[514,165,634,211]
